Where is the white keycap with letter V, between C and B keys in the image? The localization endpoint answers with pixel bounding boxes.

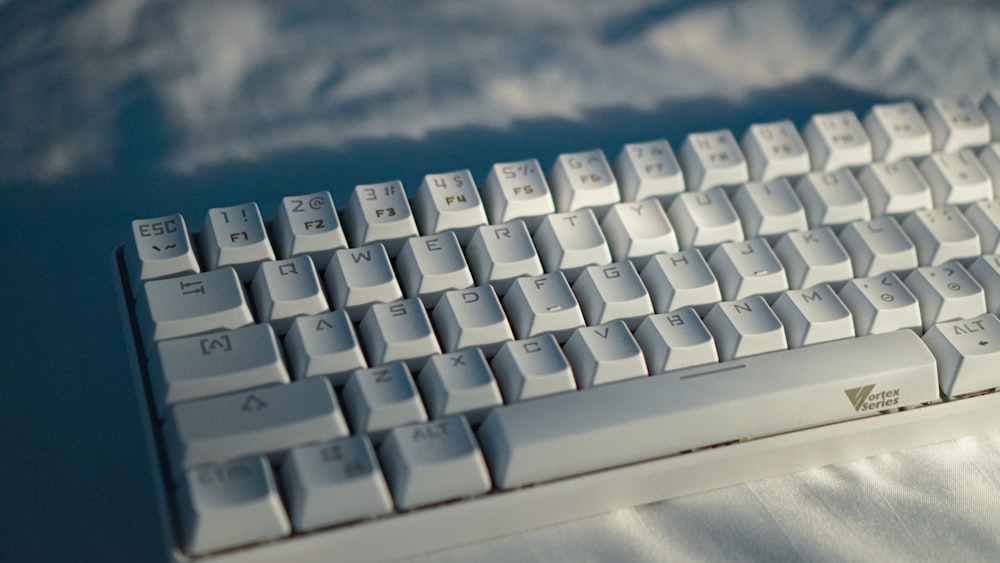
[563,321,647,389]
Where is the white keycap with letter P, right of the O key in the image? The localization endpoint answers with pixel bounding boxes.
[857,162,934,217]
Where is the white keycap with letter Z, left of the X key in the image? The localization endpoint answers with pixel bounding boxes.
[341,362,427,445]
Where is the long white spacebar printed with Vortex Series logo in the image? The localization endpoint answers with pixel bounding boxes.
[478,330,938,489]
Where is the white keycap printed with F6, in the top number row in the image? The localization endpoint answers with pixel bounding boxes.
[549,149,621,216]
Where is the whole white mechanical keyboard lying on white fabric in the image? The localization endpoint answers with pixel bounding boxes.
[115,92,1000,561]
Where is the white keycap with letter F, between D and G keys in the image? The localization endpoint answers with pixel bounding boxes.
[503,272,584,343]
